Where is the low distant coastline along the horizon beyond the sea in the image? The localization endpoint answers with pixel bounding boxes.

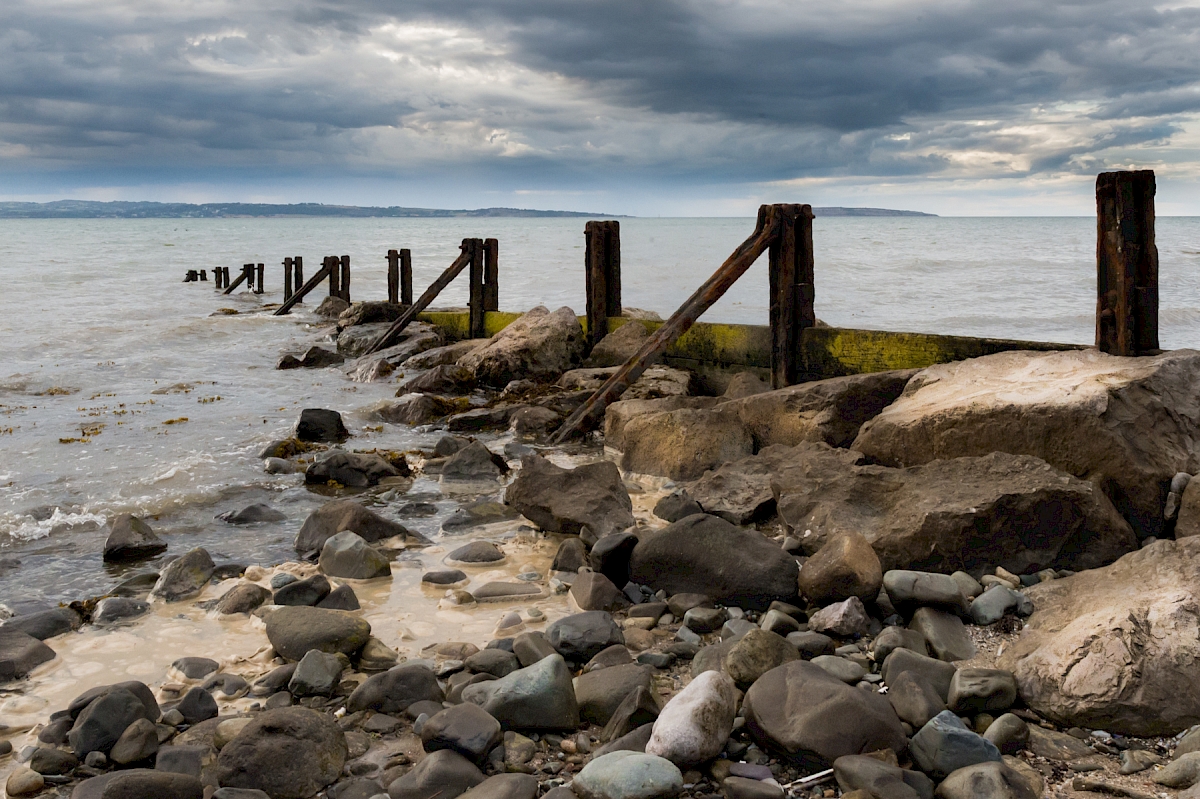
[0,200,937,220]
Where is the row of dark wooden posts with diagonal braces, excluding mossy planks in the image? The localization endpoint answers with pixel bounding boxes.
[199,170,1159,441]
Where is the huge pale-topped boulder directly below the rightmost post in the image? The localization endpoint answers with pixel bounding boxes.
[853,349,1200,537]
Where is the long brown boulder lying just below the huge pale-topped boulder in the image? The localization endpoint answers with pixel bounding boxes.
[772,444,1136,575]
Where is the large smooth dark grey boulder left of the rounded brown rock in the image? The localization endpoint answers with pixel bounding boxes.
[629,513,799,609]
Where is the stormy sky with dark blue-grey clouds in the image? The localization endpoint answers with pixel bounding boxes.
[0,0,1200,216]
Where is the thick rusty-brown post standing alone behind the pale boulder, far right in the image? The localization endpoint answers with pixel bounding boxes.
[1096,169,1159,355]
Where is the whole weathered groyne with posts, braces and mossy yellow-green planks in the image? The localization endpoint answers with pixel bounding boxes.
[201,170,1159,427]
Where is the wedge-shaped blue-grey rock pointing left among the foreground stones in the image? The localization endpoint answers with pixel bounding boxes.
[462,655,580,729]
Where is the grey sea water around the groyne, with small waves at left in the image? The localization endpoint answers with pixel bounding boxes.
[0,217,1200,601]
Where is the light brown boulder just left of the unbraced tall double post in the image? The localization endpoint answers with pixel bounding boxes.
[458,306,586,389]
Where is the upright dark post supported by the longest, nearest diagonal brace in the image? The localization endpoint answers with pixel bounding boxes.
[769,205,816,389]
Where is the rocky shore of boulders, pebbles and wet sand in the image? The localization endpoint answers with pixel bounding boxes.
[0,299,1200,799]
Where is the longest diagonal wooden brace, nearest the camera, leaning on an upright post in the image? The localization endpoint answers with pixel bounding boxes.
[553,205,780,444]
